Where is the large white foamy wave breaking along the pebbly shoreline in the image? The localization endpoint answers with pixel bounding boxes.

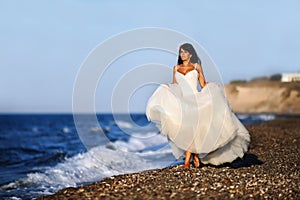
[1,139,173,196]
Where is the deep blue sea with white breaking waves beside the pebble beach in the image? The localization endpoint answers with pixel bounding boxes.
[0,113,276,199]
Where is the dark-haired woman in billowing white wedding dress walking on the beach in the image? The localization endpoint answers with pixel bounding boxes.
[146,43,250,168]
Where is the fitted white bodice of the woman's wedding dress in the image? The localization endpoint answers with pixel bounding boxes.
[175,69,198,96]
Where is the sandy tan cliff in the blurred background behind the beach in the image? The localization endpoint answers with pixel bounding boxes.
[225,80,300,114]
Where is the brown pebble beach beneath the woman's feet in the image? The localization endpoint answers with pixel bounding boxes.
[38,118,300,199]
